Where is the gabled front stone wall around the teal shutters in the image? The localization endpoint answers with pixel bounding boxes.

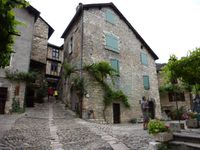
[83,8,161,122]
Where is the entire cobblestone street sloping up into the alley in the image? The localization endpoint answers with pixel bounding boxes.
[0,100,150,150]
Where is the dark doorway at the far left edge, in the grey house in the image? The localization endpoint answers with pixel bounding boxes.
[0,87,8,114]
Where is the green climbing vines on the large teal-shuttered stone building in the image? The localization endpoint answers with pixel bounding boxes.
[63,61,130,120]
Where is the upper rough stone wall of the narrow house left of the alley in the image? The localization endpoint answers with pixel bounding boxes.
[31,17,49,64]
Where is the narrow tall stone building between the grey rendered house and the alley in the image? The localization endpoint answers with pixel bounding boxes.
[26,16,54,106]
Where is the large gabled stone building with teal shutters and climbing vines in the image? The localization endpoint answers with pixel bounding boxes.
[61,3,161,123]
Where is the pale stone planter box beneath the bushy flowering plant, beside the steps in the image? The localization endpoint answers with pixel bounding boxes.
[154,132,173,142]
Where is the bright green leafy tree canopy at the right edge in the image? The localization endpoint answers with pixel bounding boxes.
[160,48,200,94]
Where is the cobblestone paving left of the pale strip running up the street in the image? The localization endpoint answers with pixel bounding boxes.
[0,105,50,150]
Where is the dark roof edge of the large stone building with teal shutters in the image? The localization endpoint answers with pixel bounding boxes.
[61,2,158,60]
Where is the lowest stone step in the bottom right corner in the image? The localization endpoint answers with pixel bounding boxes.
[170,141,200,150]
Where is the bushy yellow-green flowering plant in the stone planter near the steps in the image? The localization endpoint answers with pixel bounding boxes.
[148,119,170,134]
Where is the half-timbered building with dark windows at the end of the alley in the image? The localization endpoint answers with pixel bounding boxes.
[45,43,63,88]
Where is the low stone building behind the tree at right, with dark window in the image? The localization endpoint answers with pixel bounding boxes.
[156,63,192,118]
